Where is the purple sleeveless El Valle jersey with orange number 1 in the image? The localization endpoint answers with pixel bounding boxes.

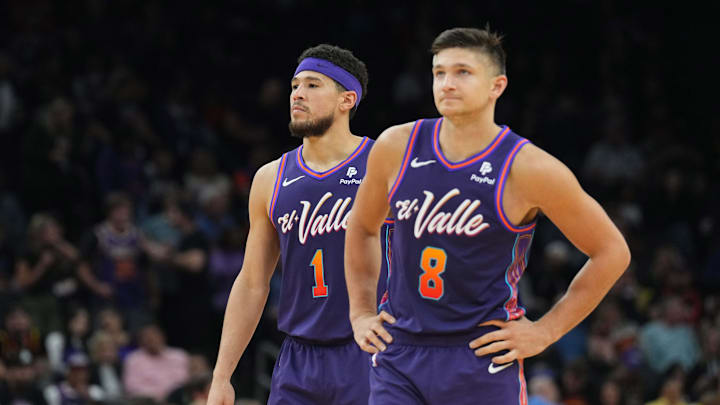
[269,137,385,342]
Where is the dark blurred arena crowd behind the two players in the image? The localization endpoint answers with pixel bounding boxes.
[0,0,720,405]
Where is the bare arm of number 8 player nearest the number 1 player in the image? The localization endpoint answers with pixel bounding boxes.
[345,123,412,353]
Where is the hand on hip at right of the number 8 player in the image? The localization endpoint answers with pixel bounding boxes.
[470,317,552,364]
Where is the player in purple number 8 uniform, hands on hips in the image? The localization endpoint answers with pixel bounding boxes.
[345,28,630,405]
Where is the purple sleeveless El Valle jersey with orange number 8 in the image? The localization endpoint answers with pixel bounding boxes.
[384,118,535,335]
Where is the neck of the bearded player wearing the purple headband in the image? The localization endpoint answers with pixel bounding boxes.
[302,121,362,172]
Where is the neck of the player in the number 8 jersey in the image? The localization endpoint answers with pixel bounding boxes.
[439,109,501,162]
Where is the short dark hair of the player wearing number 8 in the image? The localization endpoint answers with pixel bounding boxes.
[430,25,506,74]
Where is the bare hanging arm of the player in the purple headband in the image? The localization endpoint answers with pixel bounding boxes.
[208,160,280,405]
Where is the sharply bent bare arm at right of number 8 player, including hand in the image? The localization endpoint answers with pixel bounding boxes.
[470,144,630,364]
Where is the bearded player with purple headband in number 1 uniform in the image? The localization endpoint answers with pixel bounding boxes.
[208,44,382,405]
